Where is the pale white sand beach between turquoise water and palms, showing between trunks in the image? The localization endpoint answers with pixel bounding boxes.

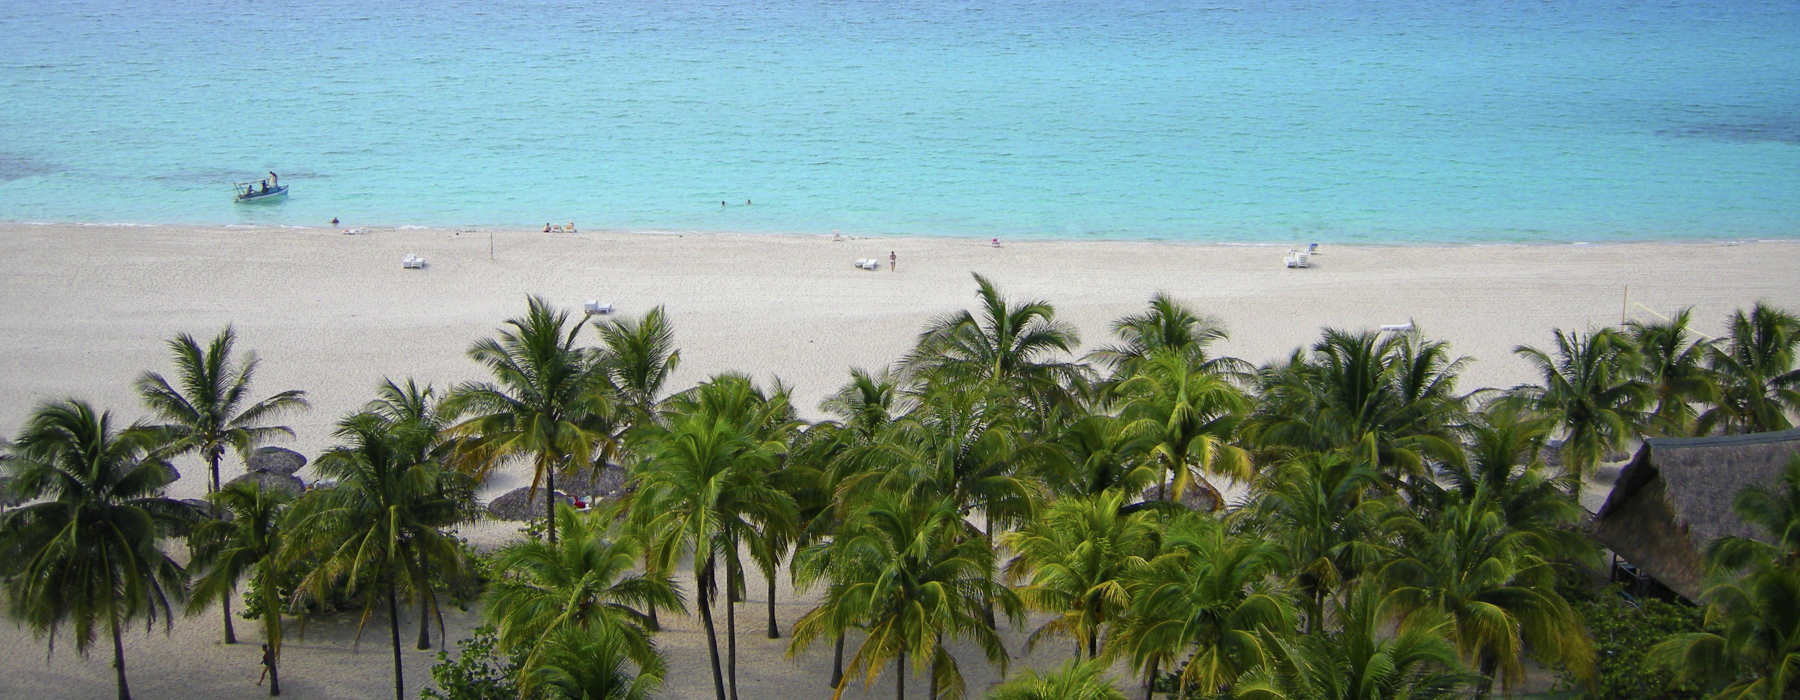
[0,223,1800,698]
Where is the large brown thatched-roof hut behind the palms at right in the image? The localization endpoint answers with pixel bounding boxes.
[1593,430,1800,599]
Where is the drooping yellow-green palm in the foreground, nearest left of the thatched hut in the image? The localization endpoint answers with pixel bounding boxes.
[1382,495,1593,696]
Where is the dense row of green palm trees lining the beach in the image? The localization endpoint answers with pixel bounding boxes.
[0,275,1800,700]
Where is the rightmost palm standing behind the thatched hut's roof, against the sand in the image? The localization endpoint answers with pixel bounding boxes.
[1699,304,1800,434]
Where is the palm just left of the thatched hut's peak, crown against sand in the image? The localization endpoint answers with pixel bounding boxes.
[1514,328,1649,479]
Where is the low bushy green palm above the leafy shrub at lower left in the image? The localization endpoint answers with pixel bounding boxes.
[482,506,684,677]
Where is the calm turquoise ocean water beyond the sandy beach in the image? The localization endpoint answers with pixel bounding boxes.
[0,0,1800,243]
